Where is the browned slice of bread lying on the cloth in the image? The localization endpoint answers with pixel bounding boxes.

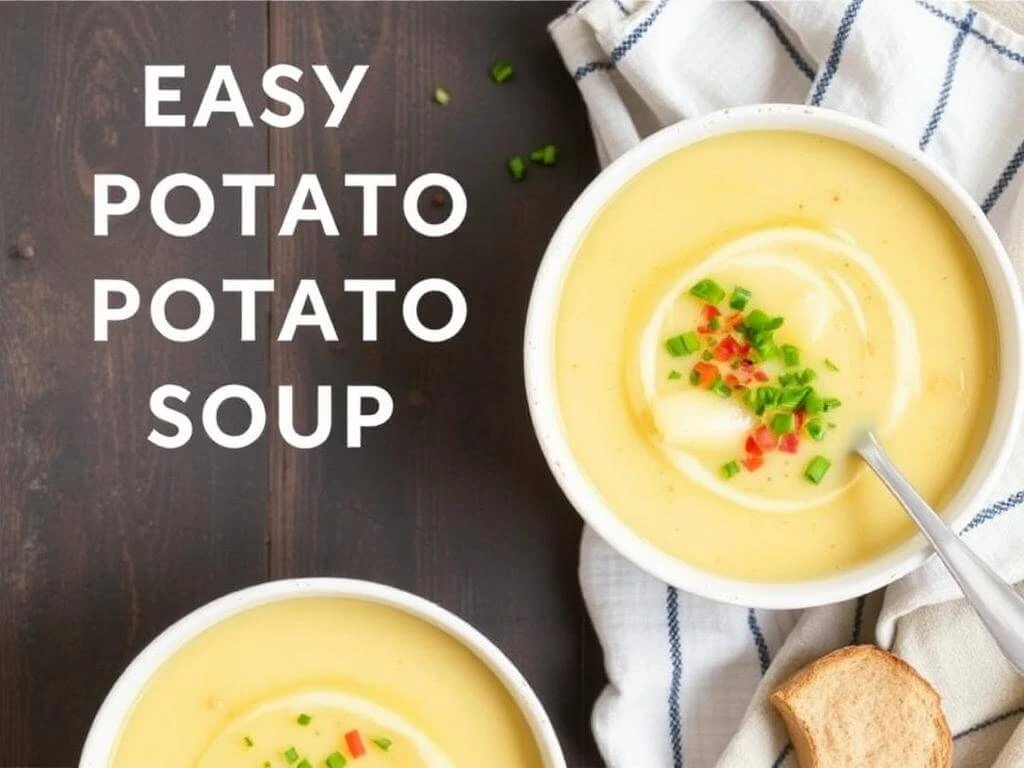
[771,645,953,768]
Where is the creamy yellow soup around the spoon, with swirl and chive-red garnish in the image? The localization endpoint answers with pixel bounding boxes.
[555,131,997,581]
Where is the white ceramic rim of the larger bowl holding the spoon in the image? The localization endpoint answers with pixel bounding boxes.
[524,104,1024,608]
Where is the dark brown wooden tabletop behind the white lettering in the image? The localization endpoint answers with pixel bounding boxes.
[0,3,602,766]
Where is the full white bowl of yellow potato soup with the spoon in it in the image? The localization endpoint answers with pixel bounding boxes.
[525,105,1022,607]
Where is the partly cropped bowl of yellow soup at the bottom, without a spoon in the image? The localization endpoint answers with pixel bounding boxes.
[79,579,565,768]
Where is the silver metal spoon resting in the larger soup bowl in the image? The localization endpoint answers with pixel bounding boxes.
[853,430,1024,675]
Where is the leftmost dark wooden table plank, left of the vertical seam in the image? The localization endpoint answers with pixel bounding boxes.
[0,4,266,766]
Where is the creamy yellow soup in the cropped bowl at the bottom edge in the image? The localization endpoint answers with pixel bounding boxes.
[112,598,543,768]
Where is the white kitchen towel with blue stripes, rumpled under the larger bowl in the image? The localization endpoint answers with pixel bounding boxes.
[551,0,1024,768]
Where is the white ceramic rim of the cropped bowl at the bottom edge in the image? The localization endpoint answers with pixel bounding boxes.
[79,579,565,768]
